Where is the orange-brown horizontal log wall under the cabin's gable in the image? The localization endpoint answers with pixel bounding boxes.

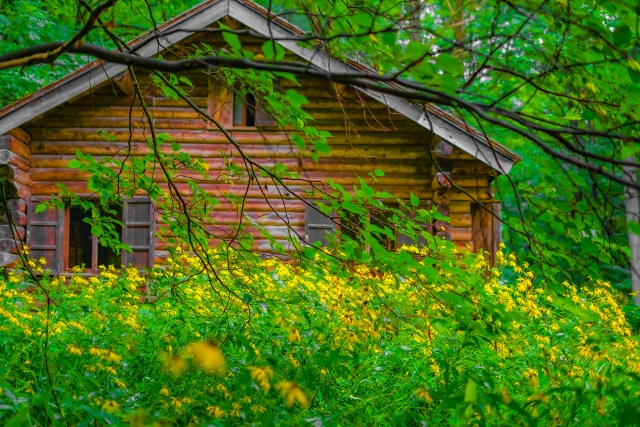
[23,28,500,261]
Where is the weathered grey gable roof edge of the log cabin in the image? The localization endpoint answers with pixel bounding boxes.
[0,0,521,173]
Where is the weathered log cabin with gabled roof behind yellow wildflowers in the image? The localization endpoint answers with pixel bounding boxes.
[0,0,520,274]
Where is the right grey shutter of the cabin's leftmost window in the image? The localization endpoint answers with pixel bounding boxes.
[122,197,156,268]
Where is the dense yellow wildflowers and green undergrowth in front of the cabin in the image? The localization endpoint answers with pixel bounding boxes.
[0,248,640,426]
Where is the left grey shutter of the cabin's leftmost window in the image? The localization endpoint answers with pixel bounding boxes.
[27,200,64,274]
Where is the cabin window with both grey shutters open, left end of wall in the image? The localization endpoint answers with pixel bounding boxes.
[27,197,155,274]
